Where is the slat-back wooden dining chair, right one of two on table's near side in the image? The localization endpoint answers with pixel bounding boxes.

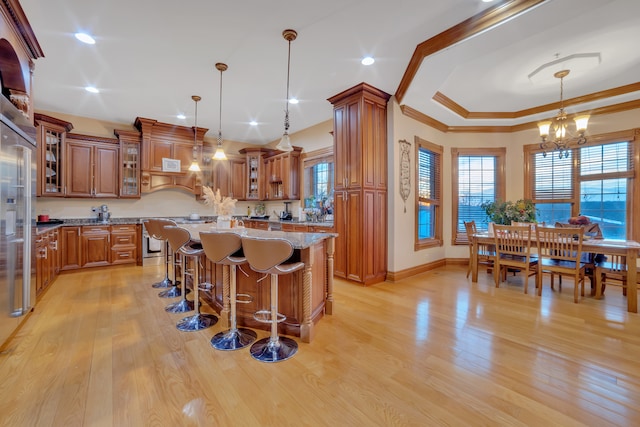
[536,227,588,303]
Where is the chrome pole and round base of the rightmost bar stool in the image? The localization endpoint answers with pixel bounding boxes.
[249,274,298,362]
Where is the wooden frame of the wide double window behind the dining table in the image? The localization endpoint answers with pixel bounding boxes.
[523,128,640,241]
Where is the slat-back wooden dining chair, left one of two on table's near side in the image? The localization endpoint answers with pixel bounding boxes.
[493,224,540,294]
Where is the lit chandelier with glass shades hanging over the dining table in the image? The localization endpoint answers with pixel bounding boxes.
[538,70,589,159]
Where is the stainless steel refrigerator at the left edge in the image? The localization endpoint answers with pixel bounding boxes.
[0,95,36,346]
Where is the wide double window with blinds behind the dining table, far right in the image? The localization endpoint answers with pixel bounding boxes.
[525,132,639,240]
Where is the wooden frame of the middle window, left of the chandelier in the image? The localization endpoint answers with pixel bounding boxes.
[451,147,507,245]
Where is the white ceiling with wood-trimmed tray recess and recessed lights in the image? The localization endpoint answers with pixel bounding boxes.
[20,0,640,145]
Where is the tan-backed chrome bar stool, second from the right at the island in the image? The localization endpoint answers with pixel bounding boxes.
[200,232,258,350]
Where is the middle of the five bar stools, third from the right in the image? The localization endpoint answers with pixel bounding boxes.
[164,226,218,332]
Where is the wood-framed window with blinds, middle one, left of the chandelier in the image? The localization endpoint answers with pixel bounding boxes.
[451,148,506,245]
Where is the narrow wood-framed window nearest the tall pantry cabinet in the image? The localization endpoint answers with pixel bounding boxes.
[415,137,442,250]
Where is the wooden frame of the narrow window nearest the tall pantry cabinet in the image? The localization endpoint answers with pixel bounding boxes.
[413,136,444,251]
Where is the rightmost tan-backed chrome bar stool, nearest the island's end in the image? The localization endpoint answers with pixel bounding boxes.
[242,237,304,362]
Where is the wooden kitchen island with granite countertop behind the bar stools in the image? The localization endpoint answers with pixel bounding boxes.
[180,224,336,342]
